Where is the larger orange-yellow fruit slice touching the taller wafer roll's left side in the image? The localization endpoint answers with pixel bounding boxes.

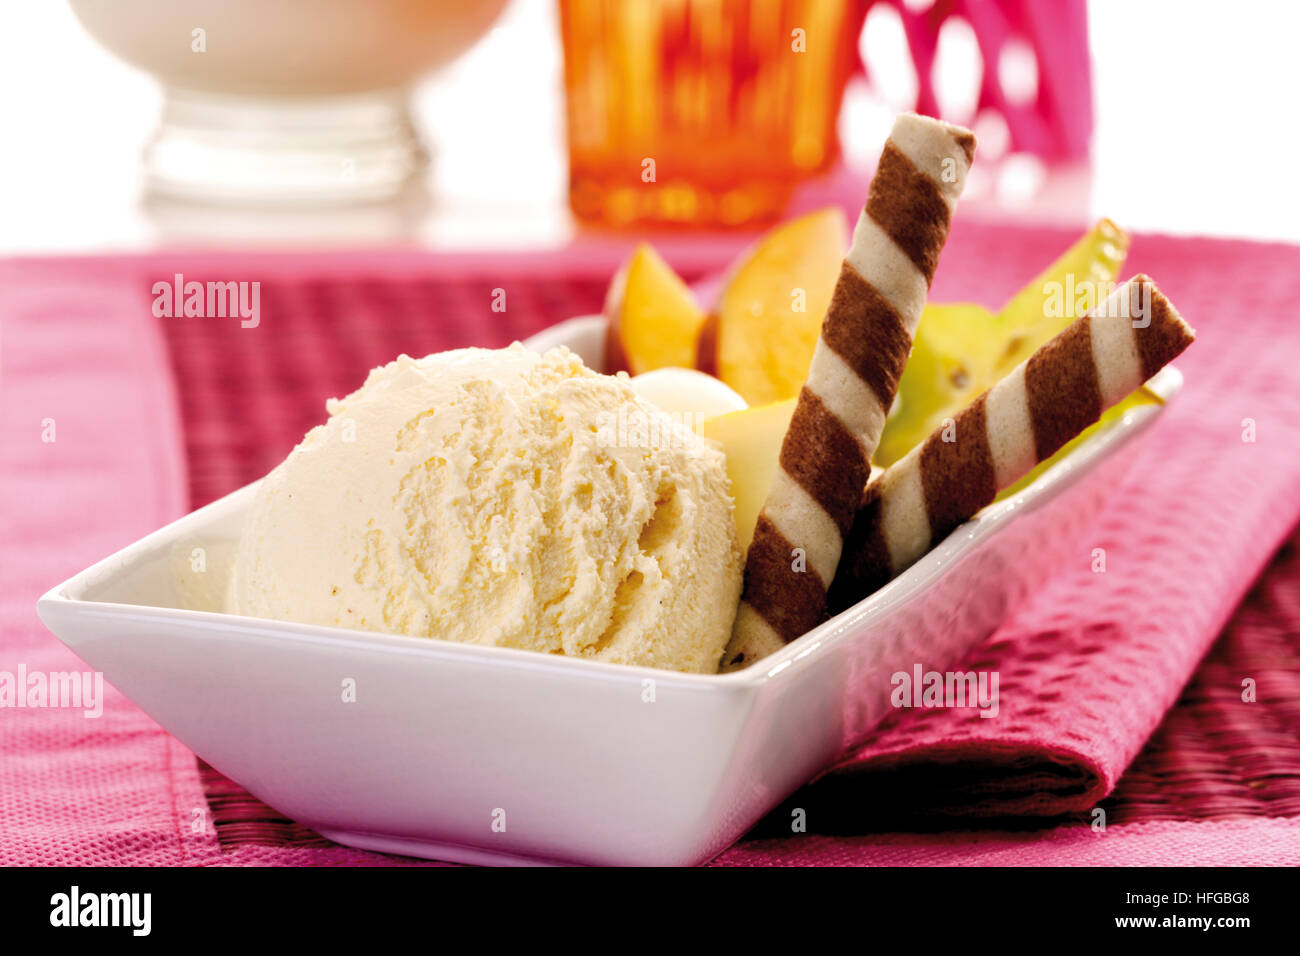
[698,207,848,406]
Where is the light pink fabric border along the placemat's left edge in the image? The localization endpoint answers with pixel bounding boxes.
[0,263,218,866]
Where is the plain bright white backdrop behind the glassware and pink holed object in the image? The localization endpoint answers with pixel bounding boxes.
[0,0,1300,254]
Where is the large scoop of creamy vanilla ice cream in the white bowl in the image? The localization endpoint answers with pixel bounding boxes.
[230,343,741,672]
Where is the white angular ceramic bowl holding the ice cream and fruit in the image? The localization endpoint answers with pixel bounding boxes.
[39,317,1182,865]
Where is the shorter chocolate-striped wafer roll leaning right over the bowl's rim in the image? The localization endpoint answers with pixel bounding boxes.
[831,276,1195,611]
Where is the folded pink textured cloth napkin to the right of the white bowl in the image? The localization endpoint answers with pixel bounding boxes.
[814,223,1300,816]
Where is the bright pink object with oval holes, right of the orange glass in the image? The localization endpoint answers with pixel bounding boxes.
[863,0,1092,160]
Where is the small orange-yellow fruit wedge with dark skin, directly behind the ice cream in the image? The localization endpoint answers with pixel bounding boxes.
[605,243,706,375]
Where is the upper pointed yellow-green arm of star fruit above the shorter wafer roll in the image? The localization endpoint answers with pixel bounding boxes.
[991,219,1130,384]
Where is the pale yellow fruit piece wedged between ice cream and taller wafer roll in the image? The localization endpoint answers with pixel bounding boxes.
[699,398,798,554]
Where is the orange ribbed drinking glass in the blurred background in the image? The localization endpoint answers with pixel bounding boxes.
[559,0,858,226]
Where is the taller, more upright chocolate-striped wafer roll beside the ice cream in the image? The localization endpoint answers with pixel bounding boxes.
[722,113,975,670]
